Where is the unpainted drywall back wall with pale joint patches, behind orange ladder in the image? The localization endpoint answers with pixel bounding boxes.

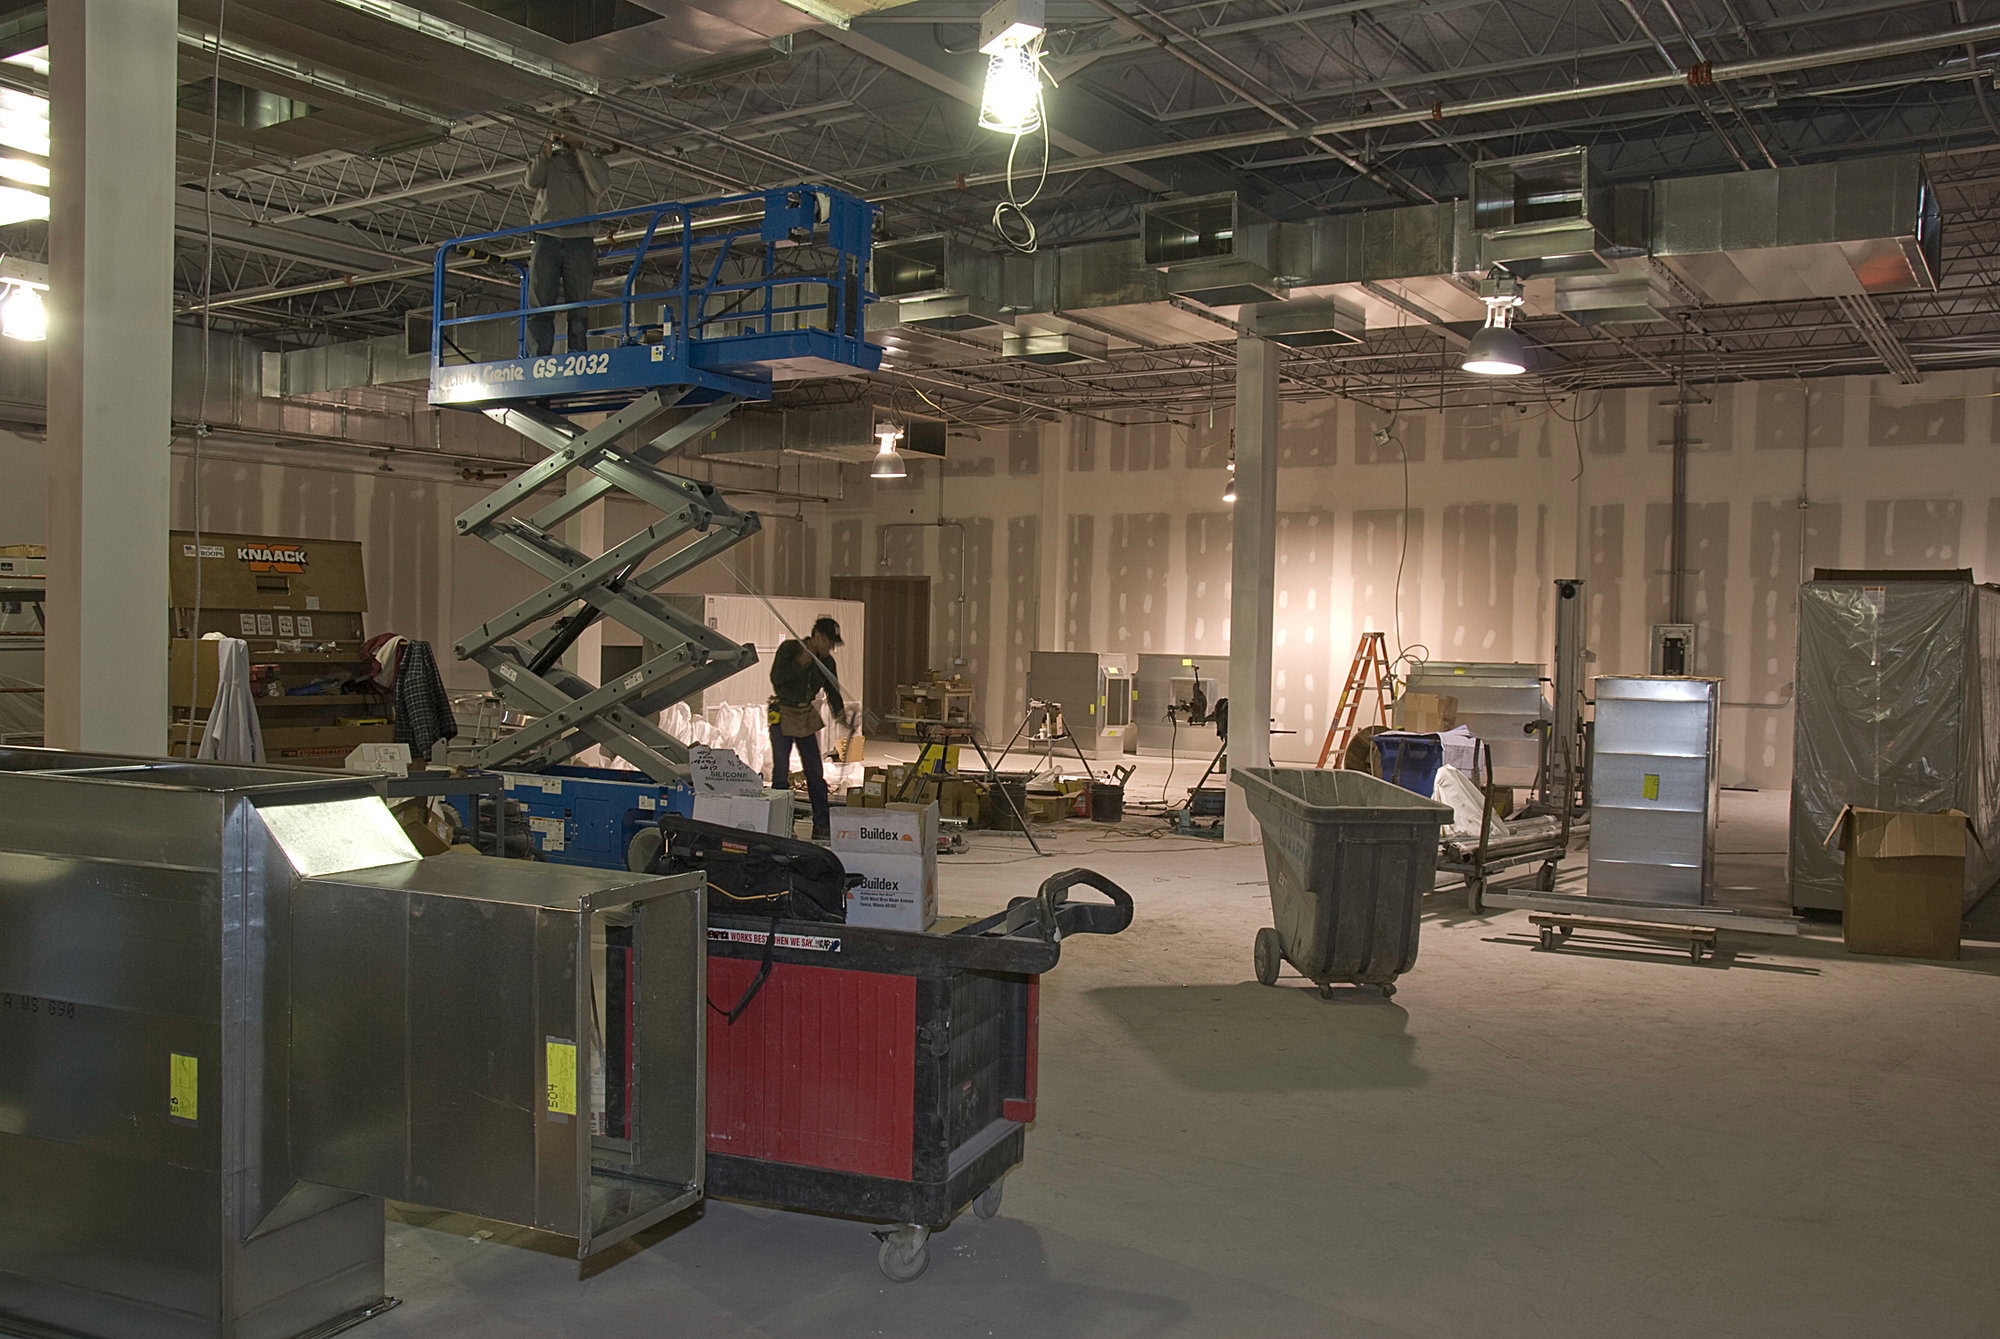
[826,370,2000,799]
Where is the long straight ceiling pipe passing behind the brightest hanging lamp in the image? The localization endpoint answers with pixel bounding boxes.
[870,22,2000,202]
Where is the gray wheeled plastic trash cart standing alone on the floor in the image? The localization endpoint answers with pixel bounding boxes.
[1230,767,1452,997]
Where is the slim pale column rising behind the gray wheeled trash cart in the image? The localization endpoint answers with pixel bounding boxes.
[1222,336,1282,841]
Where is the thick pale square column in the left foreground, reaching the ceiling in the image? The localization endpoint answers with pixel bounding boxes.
[46,0,178,753]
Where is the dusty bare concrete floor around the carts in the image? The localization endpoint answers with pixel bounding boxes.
[360,763,2000,1339]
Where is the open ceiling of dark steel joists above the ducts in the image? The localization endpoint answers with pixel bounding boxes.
[0,0,2000,422]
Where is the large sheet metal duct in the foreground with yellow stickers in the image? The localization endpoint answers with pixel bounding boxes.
[0,749,706,1339]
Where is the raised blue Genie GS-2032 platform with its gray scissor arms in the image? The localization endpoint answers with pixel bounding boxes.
[430,186,882,783]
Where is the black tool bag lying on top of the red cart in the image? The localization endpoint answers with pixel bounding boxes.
[644,813,860,921]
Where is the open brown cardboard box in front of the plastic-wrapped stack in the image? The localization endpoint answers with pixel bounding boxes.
[1826,805,1970,959]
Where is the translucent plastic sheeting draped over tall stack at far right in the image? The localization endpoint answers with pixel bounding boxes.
[1790,580,2000,909]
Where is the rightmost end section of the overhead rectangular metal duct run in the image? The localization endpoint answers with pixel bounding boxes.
[1652,154,1940,302]
